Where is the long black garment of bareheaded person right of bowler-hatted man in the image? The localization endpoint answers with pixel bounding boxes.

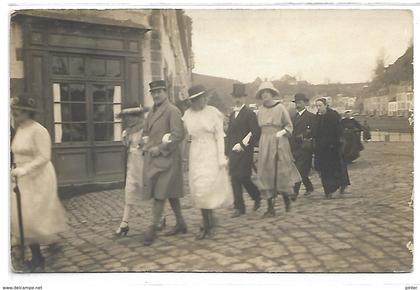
[312,108,350,194]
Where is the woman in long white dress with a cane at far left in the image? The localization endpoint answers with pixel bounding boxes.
[11,95,67,271]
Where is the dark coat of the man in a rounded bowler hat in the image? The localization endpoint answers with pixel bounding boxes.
[290,110,315,176]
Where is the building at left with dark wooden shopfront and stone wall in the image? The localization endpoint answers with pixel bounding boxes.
[10,9,193,185]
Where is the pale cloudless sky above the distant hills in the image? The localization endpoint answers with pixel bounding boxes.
[187,10,412,84]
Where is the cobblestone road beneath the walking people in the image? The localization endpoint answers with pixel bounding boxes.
[10,143,413,272]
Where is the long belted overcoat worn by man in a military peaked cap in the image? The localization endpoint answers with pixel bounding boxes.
[143,100,185,199]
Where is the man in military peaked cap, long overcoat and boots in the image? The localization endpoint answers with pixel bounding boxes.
[143,80,187,246]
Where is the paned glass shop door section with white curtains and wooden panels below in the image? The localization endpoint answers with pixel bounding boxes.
[51,55,124,185]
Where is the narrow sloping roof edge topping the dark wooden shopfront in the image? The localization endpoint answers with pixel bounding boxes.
[12,9,151,30]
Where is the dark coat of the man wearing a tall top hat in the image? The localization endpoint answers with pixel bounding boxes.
[225,106,261,177]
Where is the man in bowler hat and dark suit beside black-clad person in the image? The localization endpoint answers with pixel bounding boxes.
[290,93,315,201]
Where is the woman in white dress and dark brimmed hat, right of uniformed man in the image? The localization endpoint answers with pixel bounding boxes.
[182,85,233,240]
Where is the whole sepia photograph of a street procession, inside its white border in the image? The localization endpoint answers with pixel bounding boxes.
[2,7,415,278]
